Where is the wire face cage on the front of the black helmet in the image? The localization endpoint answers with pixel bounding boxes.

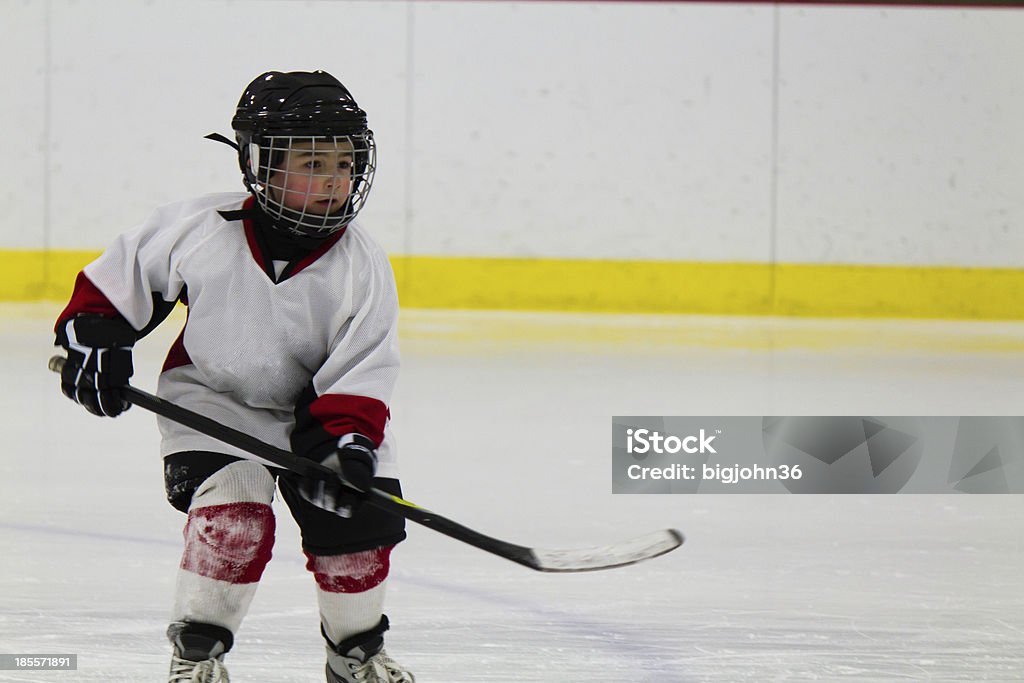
[247,130,377,237]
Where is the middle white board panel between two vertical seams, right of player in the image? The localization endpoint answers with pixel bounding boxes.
[408,2,772,261]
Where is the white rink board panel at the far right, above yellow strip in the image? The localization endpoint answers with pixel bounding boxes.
[777,7,1024,267]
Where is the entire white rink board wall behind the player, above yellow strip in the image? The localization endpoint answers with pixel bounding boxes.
[0,0,1024,267]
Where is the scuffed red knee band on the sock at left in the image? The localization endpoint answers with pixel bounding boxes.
[181,503,274,584]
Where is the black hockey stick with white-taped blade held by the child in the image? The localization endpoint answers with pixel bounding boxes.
[49,355,683,572]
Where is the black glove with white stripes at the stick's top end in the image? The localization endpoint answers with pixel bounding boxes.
[57,315,138,418]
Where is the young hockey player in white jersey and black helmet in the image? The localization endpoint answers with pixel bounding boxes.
[55,72,414,683]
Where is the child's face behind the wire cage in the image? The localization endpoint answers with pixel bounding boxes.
[267,140,352,215]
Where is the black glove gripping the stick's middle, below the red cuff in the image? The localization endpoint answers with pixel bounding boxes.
[298,434,377,517]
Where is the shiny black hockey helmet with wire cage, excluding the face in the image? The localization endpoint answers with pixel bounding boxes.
[231,71,377,237]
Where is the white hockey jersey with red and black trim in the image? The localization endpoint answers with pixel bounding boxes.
[60,193,398,478]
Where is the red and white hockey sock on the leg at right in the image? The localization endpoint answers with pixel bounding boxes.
[306,546,393,643]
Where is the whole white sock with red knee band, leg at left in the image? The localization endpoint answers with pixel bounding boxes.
[172,461,274,633]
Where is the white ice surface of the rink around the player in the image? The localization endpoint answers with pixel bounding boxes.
[0,305,1024,683]
